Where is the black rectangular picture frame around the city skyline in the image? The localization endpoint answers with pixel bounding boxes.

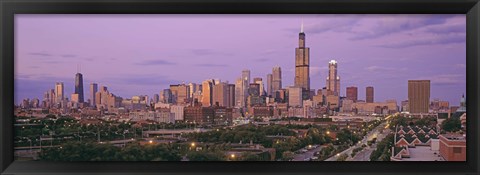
[0,0,480,175]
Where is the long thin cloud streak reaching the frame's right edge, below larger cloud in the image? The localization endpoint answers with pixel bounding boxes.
[377,34,466,48]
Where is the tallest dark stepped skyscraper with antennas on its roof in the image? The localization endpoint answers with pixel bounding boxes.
[295,22,310,91]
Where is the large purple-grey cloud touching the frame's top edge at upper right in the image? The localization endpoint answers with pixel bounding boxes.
[350,15,447,40]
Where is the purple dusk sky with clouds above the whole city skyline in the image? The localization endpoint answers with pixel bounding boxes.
[15,14,466,105]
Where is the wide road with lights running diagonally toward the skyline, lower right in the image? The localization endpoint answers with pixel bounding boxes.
[325,122,386,161]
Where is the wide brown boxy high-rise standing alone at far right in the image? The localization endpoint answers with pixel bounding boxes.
[408,80,430,113]
